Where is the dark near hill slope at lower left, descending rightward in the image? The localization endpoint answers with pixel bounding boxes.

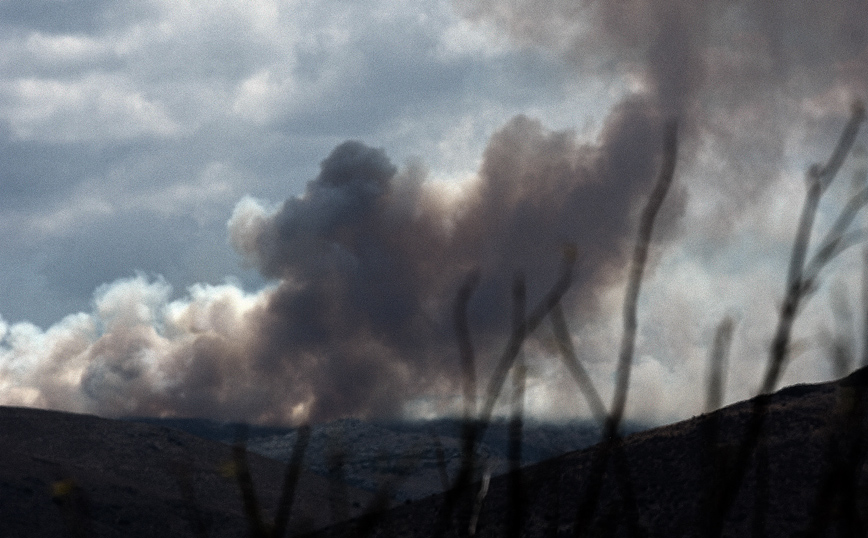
[0,407,371,538]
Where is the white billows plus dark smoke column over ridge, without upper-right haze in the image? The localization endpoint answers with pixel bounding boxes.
[0,97,684,422]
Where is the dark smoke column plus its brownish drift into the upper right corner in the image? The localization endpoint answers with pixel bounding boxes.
[197,0,868,419]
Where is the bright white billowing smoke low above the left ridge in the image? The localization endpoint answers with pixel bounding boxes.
[0,275,270,418]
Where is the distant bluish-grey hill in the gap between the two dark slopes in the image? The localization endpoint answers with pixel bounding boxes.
[128,418,647,501]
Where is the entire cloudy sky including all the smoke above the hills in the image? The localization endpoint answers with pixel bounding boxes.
[0,0,868,423]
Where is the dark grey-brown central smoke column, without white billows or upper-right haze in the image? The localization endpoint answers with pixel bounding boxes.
[214,99,677,419]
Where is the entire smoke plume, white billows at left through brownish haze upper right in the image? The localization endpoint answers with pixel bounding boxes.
[0,0,868,423]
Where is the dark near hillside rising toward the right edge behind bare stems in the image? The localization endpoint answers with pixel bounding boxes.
[316,370,868,538]
